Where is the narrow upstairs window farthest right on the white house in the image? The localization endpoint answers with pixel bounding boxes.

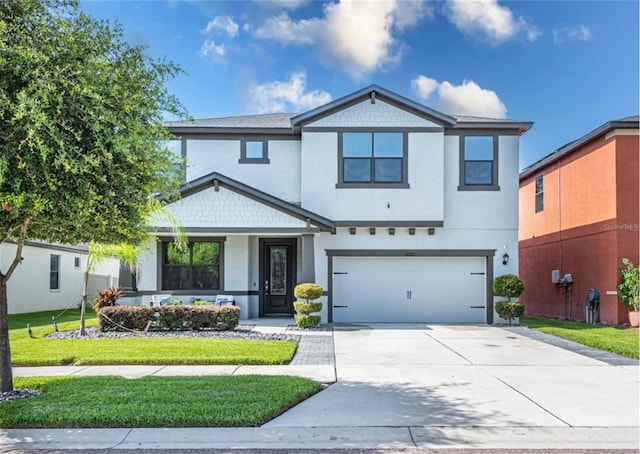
[458,135,500,191]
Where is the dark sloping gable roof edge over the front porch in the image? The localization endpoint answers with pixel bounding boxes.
[180,172,336,232]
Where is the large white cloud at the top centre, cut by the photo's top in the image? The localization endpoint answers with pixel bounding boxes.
[254,0,433,80]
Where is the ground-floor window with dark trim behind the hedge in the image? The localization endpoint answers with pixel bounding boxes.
[162,240,222,290]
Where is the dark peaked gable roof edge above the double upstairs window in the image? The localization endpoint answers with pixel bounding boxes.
[291,84,456,126]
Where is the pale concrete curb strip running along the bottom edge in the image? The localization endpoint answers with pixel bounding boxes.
[0,426,638,452]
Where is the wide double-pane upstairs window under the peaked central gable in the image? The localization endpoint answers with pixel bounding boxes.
[337,132,408,187]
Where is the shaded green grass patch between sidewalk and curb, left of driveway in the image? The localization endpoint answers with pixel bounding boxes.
[0,376,322,428]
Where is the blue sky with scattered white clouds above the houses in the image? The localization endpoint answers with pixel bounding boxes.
[81,0,639,168]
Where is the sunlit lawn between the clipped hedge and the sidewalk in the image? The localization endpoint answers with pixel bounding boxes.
[9,310,297,366]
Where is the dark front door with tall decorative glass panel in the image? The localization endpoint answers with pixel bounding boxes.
[260,238,296,316]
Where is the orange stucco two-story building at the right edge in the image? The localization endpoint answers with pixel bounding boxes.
[518,116,640,325]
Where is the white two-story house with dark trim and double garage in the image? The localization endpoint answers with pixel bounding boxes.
[133,85,532,323]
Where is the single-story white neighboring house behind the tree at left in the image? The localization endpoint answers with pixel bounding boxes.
[0,242,120,314]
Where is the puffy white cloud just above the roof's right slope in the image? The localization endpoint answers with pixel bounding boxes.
[411,75,507,118]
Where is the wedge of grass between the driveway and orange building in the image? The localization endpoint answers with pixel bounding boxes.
[520,316,640,359]
